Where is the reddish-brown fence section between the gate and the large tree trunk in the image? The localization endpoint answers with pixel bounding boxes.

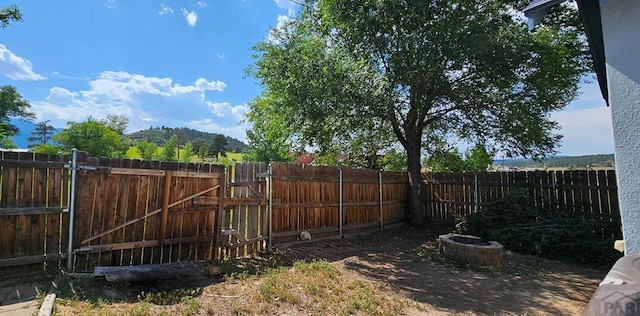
[271,163,409,243]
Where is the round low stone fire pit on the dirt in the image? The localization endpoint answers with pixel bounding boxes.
[439,234,504,268]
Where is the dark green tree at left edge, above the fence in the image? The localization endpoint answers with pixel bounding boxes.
[0,86,35,137]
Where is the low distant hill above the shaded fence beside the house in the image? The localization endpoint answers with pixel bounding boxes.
[493,154,615,168]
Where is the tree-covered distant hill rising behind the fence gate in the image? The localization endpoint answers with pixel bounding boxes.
[127,126,247,153]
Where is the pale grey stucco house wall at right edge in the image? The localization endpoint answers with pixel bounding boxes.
[600,0,640,255]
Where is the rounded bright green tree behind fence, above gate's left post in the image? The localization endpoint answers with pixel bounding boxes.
[52,117,127,158]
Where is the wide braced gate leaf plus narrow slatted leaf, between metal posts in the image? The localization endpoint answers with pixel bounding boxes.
[73,158,268,271]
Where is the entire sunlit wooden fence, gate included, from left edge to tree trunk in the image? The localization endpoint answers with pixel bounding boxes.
[0,152,408,271]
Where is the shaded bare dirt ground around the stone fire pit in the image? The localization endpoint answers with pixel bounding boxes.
[278,226,607,315]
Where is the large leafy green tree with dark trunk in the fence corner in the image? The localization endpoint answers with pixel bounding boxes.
[249,0,588,226]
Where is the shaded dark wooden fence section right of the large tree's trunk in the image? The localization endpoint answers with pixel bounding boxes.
[422,170,620,223]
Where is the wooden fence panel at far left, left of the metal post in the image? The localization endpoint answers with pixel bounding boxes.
[0,152,69,267]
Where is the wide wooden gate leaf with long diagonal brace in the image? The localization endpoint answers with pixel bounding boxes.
[73,158,226,271]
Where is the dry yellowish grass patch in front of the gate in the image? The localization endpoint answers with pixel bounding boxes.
[48,260,415,316]
